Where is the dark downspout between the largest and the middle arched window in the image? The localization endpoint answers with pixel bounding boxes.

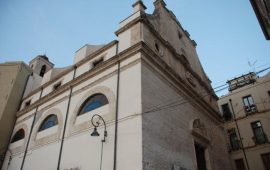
[57,65,77,170]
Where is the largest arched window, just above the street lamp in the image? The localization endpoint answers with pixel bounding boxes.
[78,93,109,115]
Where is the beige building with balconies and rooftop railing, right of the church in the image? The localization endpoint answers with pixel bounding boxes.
[218,72,270,170]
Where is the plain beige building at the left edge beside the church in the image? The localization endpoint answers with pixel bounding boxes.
[0,62,32,167]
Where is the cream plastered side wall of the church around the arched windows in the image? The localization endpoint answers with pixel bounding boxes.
[3,51,142,170]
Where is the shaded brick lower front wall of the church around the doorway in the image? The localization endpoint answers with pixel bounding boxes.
[142,64,230,170]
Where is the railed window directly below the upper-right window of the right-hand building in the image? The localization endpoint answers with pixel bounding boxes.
[251,121,268,144]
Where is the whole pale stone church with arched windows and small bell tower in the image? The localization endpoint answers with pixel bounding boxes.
[2,0,231,170]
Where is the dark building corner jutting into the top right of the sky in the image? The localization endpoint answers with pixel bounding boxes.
[250,0,270,40]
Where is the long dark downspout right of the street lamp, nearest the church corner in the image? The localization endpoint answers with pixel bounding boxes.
[113,42,120,170]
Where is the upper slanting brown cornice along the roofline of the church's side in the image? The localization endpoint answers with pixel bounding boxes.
[22,40,118,100]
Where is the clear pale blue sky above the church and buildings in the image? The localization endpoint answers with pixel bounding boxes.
[0,0,270,95]
